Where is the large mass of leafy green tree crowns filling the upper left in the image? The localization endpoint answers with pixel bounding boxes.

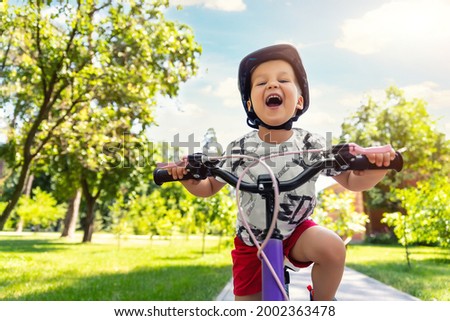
[0,0,201,234]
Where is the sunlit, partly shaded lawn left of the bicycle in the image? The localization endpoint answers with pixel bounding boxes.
[0,233,231,301]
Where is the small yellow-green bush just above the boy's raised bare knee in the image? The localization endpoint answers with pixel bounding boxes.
[314,190,369,241]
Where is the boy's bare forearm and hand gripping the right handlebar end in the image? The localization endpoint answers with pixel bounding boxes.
[333,149,395,192]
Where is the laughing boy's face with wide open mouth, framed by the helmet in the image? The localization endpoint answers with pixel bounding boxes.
[247,60,303,126]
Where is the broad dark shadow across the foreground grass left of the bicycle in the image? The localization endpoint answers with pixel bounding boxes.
[5,266,231,301]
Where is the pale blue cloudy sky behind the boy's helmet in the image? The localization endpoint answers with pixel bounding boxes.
[149,0,450,147]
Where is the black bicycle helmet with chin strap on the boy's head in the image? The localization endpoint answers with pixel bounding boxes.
[238,44,309,129]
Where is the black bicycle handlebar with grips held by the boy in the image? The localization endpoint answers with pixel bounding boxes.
[153,144,403,193]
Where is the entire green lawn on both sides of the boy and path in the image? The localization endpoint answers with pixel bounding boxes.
[0,233,450,301]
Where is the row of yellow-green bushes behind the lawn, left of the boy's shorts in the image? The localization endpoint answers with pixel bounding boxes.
[110,184,236,237]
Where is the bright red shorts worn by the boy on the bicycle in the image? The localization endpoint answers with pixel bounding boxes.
[231,220,317,296]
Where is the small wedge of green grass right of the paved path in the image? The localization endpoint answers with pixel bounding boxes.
[347,245,450,301]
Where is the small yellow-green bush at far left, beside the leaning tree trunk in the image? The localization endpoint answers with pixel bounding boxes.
[16,188,67,228]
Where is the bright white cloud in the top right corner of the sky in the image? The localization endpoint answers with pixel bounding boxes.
[335,0,450,58]
